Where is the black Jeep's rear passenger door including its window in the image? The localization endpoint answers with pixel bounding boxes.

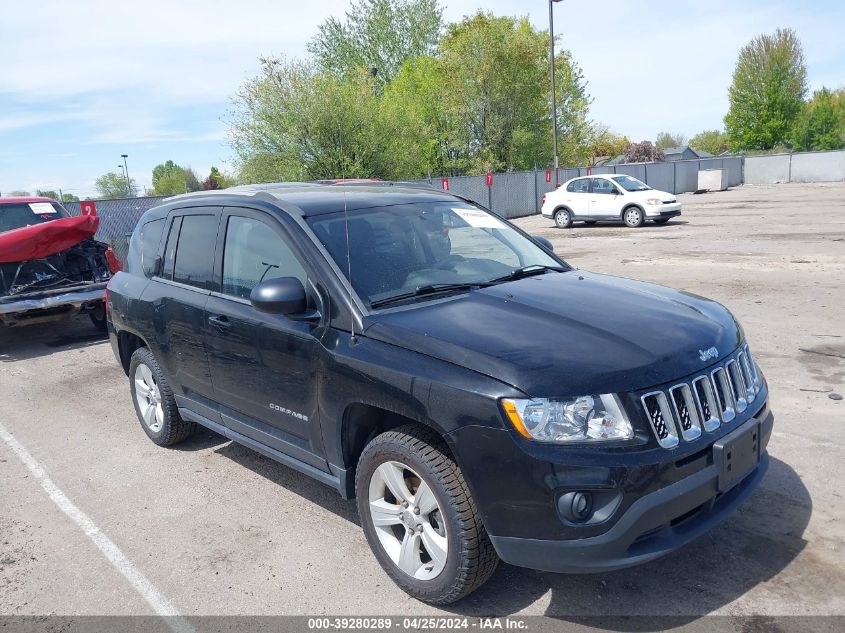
[144,207,221,419]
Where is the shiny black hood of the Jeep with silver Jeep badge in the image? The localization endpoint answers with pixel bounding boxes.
[365,270,742,397]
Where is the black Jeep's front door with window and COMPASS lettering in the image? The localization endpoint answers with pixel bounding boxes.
[206,208,327,470]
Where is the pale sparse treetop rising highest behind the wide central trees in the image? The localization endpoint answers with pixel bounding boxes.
[308,0,443,84]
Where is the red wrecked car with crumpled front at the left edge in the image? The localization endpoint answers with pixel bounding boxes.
[0,198,119,331]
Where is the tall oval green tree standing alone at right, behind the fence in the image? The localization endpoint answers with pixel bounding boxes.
[725,29,807,151]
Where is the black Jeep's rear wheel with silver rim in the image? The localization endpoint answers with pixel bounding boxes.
[129,347,197,446]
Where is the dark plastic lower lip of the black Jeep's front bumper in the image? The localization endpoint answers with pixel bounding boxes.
[490,446,769,573]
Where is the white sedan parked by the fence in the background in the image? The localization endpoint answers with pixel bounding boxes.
[542,174,681,229]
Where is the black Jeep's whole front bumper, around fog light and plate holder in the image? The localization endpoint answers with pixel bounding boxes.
[452,390,774,573]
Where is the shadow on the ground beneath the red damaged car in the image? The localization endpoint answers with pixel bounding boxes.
[0,316,108,363]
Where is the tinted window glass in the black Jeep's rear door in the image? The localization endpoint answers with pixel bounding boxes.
[173,215,218,290]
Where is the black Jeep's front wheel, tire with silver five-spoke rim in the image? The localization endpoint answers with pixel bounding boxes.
[355,425,499,605]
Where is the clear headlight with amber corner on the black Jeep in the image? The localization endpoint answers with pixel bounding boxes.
[502,393,634,444]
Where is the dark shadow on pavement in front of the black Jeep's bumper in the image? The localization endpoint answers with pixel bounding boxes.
[448,458,816,631]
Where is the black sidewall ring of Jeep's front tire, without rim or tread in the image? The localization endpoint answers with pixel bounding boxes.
[355,434,462,602]
